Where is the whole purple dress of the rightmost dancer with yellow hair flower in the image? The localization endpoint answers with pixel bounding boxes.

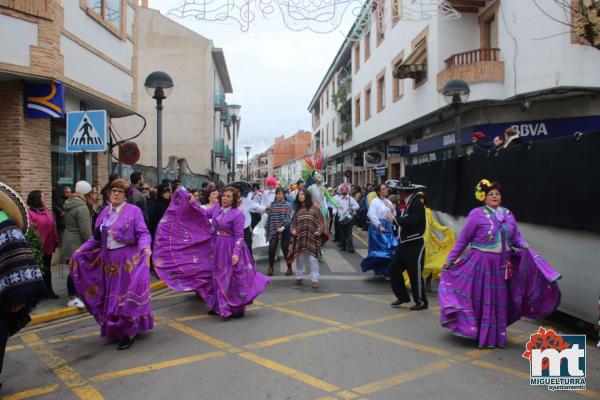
[438,207,560,348]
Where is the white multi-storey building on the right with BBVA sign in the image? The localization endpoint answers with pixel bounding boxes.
[309,0,600,184]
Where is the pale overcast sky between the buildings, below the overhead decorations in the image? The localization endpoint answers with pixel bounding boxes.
[149,0,354,160]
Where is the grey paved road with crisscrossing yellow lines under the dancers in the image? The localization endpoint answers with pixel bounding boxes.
[0,242,600,400]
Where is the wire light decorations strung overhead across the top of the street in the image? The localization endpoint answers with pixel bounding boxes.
[169,0,460,37]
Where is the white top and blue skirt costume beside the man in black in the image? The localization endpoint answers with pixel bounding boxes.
[360,197,398,277]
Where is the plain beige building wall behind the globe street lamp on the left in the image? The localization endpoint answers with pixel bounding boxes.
[112,6,233,187]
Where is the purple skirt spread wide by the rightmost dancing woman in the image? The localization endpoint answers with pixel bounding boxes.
[438,249,560,348]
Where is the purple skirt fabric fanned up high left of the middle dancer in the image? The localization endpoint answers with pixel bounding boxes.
[152,189,215,309]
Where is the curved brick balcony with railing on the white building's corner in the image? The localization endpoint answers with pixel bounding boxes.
[437,49,504,90]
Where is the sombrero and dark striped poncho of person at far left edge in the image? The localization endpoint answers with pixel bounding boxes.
[0,182,48,386]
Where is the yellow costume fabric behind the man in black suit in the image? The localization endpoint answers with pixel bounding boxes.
[404,207,456,287]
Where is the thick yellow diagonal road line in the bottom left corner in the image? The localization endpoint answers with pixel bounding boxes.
[21,333,104,400]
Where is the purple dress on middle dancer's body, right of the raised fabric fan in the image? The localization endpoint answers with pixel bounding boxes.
[210,206,270,317]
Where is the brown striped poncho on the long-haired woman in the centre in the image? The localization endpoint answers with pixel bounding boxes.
[288,205,325,262]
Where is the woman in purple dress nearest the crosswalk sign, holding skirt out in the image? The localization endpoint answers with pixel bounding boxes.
[71,179,154,350]
